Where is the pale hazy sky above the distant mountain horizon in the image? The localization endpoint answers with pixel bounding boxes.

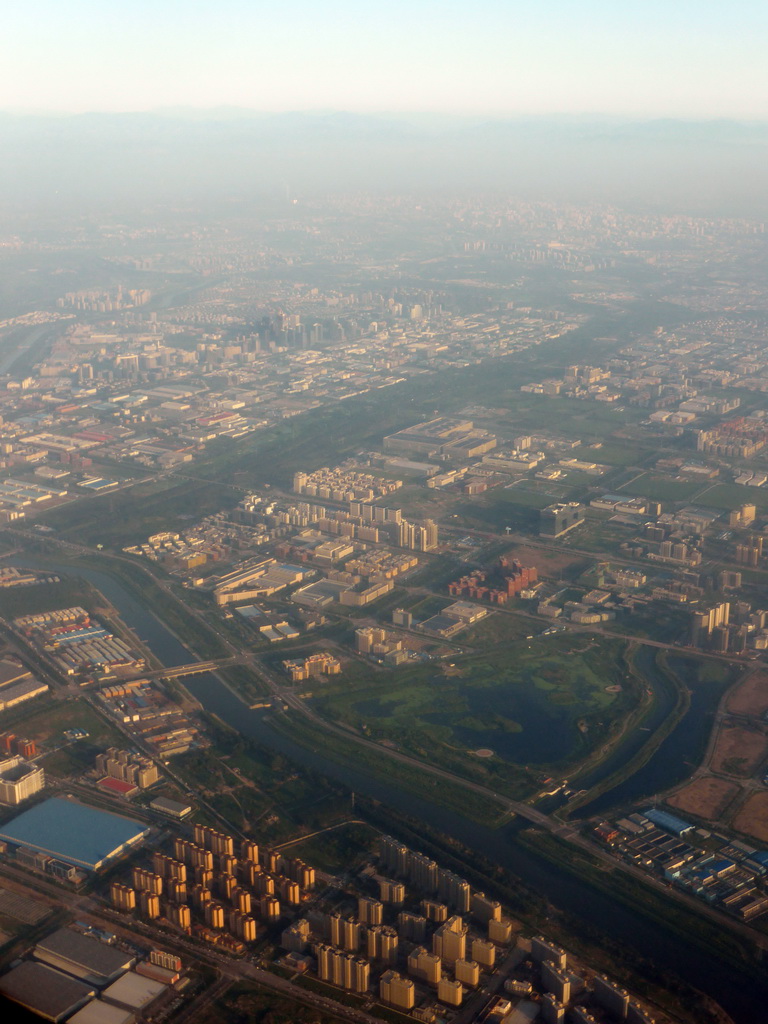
[6,0,768,119]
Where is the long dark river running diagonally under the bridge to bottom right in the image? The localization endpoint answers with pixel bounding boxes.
[11,557,768,1024]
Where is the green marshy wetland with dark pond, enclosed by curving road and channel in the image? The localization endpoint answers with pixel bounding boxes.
[305,630,638,792]
